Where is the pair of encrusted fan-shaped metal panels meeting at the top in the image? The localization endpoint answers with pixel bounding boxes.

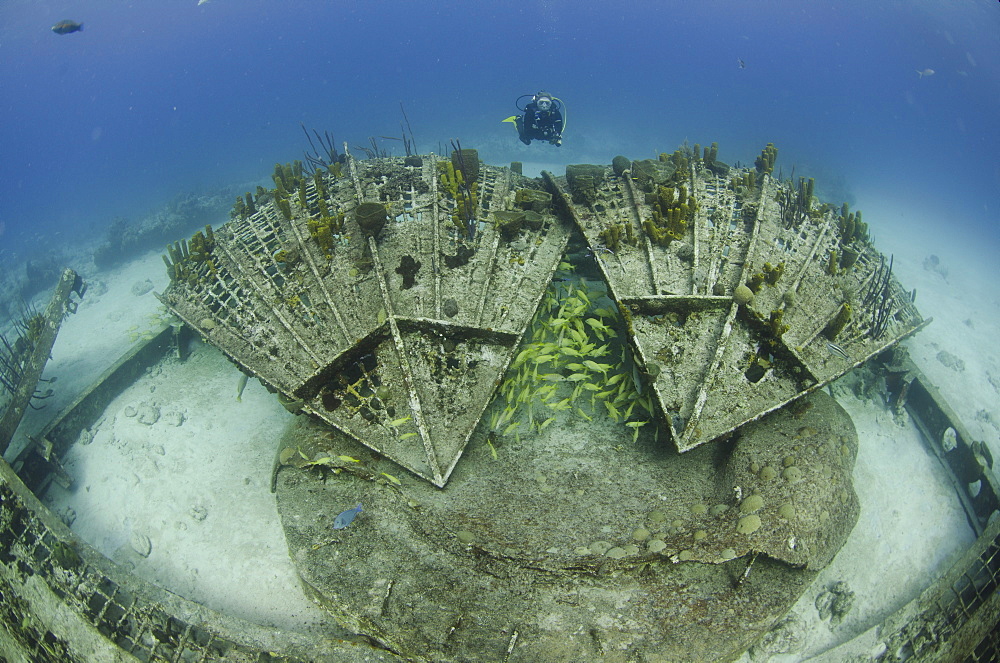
[163,145,925,486]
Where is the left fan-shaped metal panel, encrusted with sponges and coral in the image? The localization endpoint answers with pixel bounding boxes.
[162,150,569,486]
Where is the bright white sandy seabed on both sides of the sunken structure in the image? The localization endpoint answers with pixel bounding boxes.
[11,179,1000,661]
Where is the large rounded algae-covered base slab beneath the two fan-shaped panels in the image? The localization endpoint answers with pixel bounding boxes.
[276,392,858,663]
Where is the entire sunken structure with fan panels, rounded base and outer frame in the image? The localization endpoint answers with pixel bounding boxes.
[0,144,1000,662]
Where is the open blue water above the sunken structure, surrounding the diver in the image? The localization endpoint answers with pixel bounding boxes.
[0,0,1000,264]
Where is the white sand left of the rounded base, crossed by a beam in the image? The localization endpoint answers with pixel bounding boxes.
[12,253,326,630]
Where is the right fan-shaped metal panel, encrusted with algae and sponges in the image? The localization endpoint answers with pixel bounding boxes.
[546,145,925,451]
